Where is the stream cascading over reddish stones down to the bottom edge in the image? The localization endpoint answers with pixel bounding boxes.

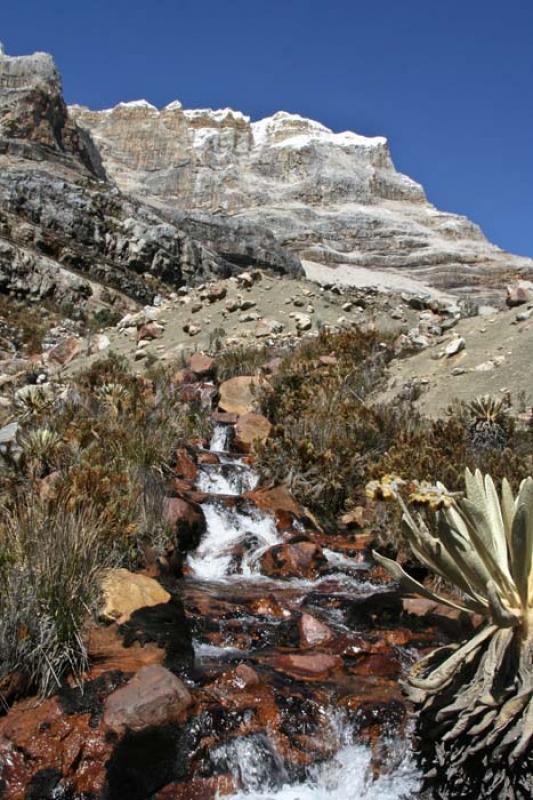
[182,425,419,800]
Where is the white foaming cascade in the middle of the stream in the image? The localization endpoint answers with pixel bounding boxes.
[187,503,281,581]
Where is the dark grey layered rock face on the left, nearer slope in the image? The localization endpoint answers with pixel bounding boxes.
[0,47,301,304]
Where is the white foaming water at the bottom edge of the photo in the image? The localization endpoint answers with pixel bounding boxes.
[214,716,419,800]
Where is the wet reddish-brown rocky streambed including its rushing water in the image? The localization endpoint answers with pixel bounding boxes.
[0,424,462,800]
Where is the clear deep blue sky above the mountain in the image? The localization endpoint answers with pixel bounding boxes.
[0,0,533,256]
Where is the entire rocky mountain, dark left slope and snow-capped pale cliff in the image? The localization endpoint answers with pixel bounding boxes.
[0,48,533,312]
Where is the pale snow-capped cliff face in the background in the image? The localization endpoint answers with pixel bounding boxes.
[70,101,533,291]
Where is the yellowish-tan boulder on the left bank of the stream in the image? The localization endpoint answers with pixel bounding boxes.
[99,568,170,624]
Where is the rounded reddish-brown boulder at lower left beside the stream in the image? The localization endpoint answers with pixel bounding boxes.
[103,664,192,733]
